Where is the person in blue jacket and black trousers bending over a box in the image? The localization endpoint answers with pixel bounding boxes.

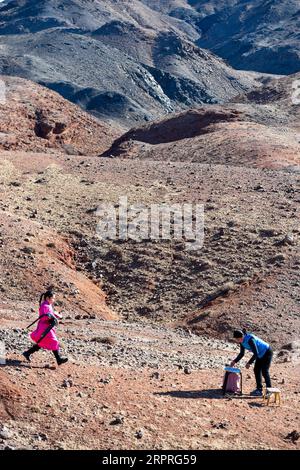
[230,329,273,396]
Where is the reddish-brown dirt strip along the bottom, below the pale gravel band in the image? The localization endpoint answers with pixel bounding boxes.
[0,357,300,450]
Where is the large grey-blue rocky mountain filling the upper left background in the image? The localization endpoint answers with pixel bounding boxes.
[0,0,258,127]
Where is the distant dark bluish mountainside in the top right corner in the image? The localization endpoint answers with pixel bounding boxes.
[196,0,300,75]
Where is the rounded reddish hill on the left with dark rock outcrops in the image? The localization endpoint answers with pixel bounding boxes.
[0,76,122,155]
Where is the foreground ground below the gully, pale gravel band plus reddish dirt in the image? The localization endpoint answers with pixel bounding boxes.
[0,302,300,450]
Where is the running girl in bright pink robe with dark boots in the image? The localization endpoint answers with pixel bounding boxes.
[23,290,68,366]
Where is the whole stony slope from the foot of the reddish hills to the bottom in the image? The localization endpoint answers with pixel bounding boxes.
[0,134,300,449]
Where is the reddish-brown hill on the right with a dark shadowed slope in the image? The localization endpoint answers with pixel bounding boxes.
[103,74,300,171]
